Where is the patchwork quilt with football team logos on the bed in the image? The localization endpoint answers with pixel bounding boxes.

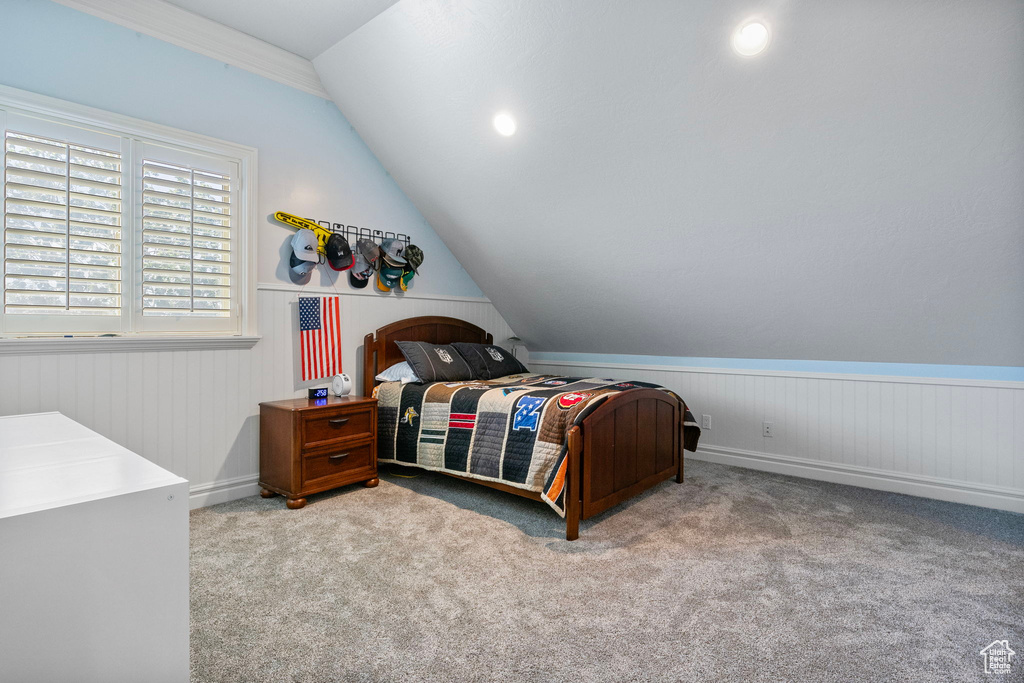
[374,374,700,516]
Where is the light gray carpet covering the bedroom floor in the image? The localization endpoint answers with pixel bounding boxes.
[191,461,1024,683]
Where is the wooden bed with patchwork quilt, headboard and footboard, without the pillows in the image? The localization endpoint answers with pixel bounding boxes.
[362,316,700,541]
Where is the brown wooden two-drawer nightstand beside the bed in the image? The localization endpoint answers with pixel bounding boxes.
[259,396,380,510]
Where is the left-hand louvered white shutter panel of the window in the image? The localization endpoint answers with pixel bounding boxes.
[3,117,124,332]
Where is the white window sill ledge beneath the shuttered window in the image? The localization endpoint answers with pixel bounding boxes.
[0,336,260,355]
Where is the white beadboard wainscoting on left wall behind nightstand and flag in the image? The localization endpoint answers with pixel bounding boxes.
[0,286,512,507]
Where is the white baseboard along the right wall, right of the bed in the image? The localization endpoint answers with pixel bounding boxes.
[686,445,1024,514]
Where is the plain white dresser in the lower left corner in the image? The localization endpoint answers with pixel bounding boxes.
[0,413,188,683]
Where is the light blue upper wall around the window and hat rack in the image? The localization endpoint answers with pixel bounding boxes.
[0,0,481,296]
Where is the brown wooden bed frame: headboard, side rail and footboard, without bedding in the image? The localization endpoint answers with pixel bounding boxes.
[362,315,683,541]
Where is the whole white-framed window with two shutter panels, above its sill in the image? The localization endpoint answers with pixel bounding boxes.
[0,87,256,337]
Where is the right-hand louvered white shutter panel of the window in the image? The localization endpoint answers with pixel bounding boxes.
[141,144,238,329]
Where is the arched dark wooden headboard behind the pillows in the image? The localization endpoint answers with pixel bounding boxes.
[362,315,495,396]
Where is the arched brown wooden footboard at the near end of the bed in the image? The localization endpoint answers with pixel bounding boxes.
[565,389,683,541]
